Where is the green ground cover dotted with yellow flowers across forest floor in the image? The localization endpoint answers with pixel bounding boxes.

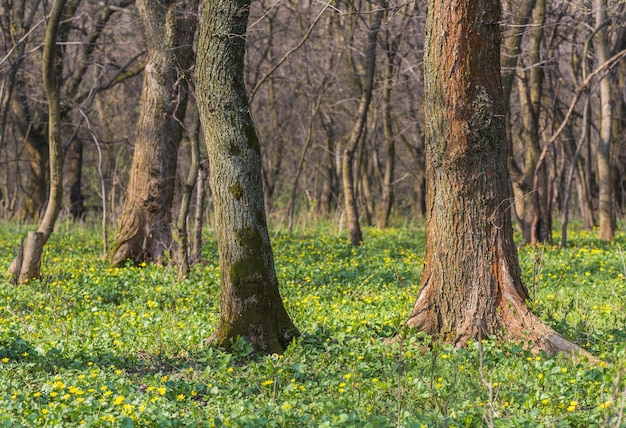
[0,224,626,427]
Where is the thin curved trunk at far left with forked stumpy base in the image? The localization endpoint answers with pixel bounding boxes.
[8,0,65,284]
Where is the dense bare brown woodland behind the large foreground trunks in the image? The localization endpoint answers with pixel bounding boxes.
[0,0,626,243]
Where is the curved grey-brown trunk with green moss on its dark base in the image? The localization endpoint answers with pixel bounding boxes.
[196,0,299,353]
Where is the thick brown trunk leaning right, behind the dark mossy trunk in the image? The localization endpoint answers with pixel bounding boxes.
[109,0,198,265]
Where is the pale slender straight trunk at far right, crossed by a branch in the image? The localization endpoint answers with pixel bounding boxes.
[593,0,615,240]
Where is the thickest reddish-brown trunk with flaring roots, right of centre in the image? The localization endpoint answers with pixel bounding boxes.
[407,0,585,353]
